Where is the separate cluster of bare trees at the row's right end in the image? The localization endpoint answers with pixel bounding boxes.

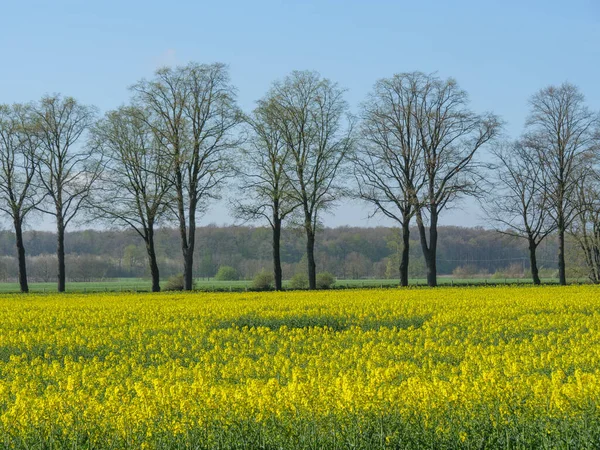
[484,83,600,285]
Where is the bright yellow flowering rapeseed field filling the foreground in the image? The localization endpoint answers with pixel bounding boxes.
[0,286,600,449]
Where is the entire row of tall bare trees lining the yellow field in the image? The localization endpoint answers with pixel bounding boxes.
[0,63,600,292]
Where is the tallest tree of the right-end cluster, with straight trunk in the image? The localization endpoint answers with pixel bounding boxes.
[526,83,599,285]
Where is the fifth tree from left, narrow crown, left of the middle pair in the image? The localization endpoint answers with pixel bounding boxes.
[233,96,300,291]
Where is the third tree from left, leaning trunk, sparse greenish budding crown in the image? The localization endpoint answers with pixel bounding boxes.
[88,107,173,292]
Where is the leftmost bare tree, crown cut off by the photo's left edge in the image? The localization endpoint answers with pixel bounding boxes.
[0,105,41,292]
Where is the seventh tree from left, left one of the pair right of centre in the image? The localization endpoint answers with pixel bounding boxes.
[353,73,425,286]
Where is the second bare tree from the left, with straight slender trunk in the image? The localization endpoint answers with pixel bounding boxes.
[33,94,102,292]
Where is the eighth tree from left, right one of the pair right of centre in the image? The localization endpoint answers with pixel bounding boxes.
[415,74,501,286]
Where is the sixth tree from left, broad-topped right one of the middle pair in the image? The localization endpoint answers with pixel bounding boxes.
[268,71,353,289]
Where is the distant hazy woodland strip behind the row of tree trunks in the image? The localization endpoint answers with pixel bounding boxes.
[0,226,587,282]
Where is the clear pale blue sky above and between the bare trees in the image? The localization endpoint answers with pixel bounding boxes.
[0,0,600,229]
